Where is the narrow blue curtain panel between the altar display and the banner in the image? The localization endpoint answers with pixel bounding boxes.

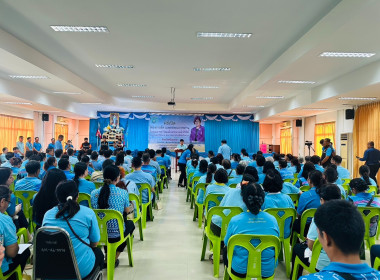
[125,118,149,151]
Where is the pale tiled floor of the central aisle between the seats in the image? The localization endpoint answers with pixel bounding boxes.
[115,176,286,280]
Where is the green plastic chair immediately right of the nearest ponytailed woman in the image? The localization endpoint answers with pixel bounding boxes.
[264,208,297,277]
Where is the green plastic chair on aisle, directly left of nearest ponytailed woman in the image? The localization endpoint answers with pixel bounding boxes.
[201,206,243,278]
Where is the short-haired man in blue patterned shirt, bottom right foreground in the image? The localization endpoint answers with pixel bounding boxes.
[300,200,380,280]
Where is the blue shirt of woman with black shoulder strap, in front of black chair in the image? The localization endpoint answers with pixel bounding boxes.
[42,206,100,278]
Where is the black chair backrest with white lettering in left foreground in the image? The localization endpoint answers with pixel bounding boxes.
[33,227,81,279]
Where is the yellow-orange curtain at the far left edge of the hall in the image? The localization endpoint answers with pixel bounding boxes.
[0,115,34,152]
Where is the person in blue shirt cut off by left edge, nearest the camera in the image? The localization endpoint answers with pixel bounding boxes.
[0,185,30,279]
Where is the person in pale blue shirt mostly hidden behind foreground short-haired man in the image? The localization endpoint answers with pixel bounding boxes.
[290,184,341,279]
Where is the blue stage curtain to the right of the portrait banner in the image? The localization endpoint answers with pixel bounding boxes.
[205,120,260,154]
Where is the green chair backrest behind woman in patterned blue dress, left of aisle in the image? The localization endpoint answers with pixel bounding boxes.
[94,209,124,246]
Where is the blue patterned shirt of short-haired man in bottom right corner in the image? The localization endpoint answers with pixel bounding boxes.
[298,262,380,280]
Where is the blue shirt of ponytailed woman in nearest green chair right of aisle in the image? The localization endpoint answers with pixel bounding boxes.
[224,212,280,277]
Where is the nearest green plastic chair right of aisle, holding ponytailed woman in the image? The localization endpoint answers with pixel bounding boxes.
[224,234,281,280]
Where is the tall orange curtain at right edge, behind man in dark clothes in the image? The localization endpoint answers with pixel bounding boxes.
[353,102,380,182]
